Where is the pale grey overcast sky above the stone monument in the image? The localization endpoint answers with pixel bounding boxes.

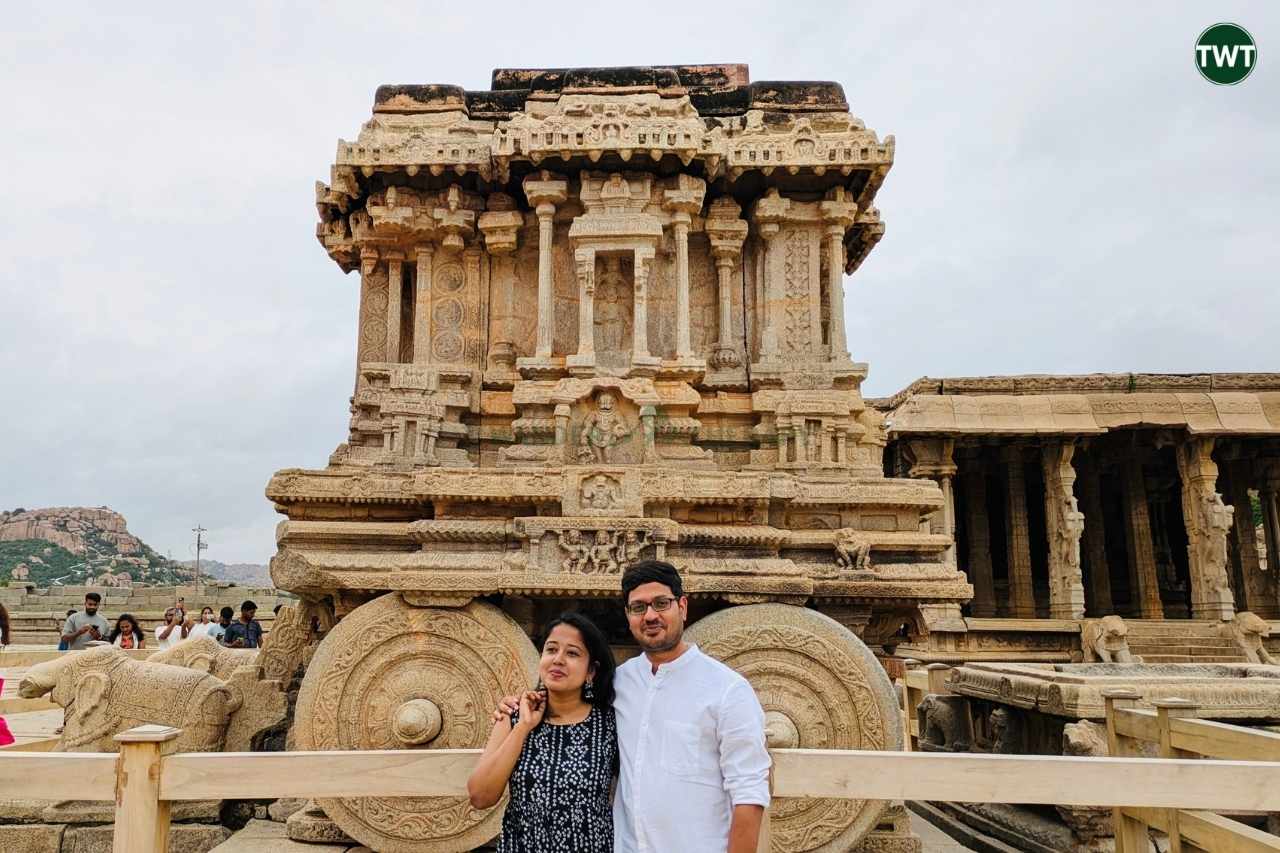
[0,0,1280,562]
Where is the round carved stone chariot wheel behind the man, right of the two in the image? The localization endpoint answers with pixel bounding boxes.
[686,605,902,853]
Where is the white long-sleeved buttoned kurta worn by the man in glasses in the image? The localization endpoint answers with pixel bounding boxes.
[613,646,769,853]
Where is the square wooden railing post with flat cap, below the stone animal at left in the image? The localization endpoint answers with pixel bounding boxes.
[111,725,182,853]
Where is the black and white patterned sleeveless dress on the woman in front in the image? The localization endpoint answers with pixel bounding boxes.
[498,707,618,853]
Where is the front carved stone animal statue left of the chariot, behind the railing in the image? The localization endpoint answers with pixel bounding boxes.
[18,646,242,752]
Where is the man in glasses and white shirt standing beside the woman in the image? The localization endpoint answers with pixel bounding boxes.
[498,560,769,853]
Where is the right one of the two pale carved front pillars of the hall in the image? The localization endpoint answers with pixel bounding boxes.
[1178,437,1235,620]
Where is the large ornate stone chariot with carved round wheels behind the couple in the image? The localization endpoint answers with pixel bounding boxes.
[268,65,972,853]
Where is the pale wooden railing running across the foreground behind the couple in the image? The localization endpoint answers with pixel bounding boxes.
[0,722,1280,853]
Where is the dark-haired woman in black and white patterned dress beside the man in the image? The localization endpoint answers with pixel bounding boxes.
[467,613,618,853]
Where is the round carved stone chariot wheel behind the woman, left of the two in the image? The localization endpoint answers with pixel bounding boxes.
[294,593,538,853]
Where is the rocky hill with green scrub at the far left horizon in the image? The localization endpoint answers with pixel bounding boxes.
[0,506,191,587]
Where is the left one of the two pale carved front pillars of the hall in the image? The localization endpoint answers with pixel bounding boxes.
[1041,441,1084,619]
